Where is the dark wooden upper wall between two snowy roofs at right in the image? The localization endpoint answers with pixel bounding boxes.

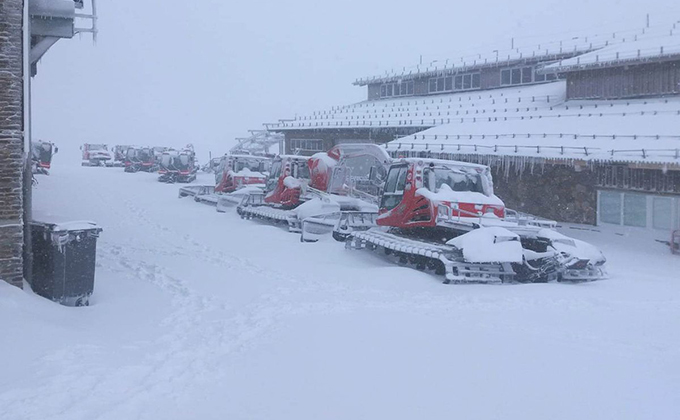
[567,61,680,99]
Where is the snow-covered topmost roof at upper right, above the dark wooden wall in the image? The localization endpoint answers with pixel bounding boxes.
[543,28,680,73]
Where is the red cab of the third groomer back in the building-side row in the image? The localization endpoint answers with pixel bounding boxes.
[215,155,271,193]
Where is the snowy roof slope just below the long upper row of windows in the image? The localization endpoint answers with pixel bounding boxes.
[269,83,566,131]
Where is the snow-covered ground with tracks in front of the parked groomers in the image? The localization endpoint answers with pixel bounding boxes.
[0,162,680,420]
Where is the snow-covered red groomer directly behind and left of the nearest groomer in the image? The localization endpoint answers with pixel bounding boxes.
[238,144,391,242]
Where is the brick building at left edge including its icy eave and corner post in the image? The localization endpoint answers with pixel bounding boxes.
[0,0,96,287]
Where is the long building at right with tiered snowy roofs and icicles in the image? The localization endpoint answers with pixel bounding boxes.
[267,24,680,237]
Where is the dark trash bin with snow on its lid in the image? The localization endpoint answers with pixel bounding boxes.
[30,221,102,306]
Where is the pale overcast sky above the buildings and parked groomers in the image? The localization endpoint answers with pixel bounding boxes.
[33,0,680,162]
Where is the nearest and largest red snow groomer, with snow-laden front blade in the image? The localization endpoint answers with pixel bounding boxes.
[346,159,605,283]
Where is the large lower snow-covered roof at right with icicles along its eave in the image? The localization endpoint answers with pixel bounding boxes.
[386,82,680,165]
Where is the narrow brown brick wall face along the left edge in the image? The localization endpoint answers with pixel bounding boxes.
[0,0,24,287]
